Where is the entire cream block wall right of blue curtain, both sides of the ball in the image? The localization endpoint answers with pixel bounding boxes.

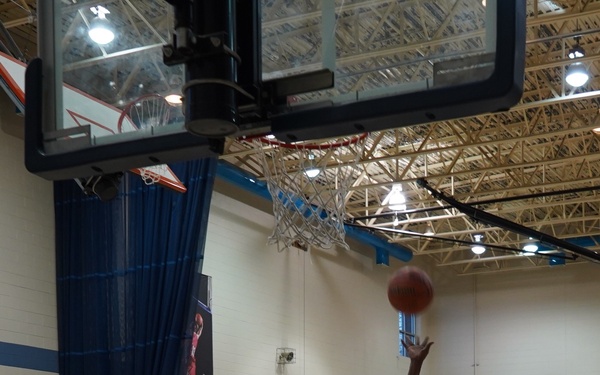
[204,189,600,375]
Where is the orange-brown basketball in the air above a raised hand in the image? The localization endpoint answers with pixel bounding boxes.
[388,266,433,314]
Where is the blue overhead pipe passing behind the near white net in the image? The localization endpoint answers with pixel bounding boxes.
[217,160,413,265]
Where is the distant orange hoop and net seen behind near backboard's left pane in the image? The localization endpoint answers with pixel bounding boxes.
[118,94,173,185]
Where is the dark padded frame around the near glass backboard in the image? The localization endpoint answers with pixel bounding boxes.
[25,0,526,180]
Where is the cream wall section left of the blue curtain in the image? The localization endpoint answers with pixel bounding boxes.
[0,122,58,374]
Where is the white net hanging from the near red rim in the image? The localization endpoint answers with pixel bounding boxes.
[254,134,367,251]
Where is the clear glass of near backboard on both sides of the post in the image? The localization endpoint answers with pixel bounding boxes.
[58,0,496,142]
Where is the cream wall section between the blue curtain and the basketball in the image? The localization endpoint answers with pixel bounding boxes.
[203,193,408,375]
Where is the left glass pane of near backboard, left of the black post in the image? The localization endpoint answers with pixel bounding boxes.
[59,0,184,142]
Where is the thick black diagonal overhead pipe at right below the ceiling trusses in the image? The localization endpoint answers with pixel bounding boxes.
[417,178,600,262]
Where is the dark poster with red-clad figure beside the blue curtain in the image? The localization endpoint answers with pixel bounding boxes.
[186,275,213,375]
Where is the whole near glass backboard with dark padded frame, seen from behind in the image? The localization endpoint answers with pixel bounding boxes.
[26,0,525,179]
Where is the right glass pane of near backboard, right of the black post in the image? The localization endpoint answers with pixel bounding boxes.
[262,0,496,104]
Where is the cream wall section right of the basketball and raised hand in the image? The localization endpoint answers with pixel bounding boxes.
[422,264,600,375]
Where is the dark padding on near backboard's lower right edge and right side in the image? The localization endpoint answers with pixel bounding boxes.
[270,0,526,142]
